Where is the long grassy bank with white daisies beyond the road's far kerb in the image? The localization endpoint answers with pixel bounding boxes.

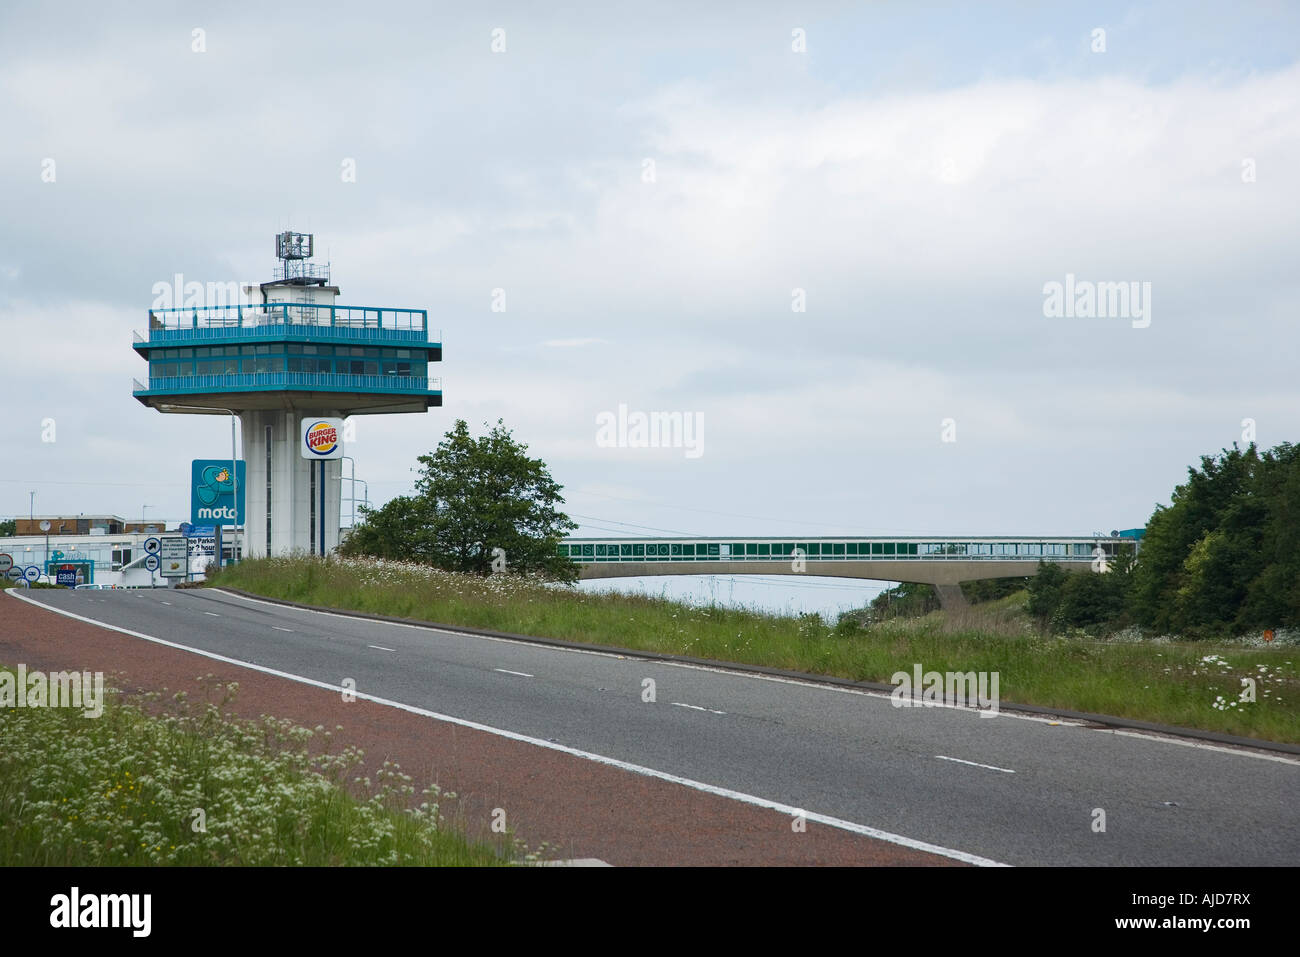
[213,558,1300,742]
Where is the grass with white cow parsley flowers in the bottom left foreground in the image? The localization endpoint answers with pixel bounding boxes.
[0,668,506,866]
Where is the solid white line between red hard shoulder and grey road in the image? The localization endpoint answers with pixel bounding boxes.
[7,589,1010,867]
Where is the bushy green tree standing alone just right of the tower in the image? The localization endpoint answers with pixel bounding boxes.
[346,420,577,581]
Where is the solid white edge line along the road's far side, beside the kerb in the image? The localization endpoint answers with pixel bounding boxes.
[205,588,1300,767]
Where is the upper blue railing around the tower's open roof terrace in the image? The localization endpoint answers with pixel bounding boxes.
[138,303,429,342]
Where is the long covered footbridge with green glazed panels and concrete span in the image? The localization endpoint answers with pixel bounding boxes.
[559,536,1138,607]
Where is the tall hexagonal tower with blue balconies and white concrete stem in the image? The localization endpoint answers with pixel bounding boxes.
[133,233,442,557]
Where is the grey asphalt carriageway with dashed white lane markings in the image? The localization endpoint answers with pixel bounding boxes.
[22,589,1300,866]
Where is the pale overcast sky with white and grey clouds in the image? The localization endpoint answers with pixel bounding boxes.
[0,3,1300,613]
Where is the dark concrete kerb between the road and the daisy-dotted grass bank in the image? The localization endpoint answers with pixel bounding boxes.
[208,586,1300,754]
